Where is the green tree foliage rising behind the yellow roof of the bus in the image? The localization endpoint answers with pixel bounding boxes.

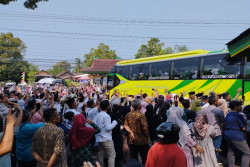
[135,38,188,59]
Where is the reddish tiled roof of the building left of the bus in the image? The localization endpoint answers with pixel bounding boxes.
[81,59,121,73]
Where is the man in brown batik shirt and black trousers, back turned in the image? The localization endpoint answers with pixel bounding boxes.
[124,100,150,165]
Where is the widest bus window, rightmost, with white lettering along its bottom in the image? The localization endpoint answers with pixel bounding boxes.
[201,54,241,79]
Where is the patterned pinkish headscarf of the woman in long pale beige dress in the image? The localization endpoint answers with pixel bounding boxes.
[194,112,209,138]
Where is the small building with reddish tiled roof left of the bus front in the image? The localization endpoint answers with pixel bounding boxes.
[81,59,121,84]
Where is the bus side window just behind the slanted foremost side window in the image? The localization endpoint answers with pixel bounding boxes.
[129,64,149,80]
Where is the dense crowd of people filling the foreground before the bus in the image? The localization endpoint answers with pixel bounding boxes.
[0,84,250,167]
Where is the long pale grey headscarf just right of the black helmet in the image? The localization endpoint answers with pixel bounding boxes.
[167,107,191,148]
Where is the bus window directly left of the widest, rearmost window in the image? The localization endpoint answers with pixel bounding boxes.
[172,58,200,79]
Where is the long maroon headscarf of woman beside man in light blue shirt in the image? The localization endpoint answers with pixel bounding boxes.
[69,114,95,150]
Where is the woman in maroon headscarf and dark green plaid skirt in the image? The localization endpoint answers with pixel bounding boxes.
[69,114,100,167]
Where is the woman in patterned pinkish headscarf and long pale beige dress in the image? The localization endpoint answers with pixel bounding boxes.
[193,113,218,167]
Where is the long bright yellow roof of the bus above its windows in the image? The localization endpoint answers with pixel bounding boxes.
[116,50,228,65]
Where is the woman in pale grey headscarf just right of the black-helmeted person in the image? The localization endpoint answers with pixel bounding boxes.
[167,107,203,167]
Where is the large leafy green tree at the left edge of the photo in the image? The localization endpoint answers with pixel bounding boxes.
[0,33,28,82]
